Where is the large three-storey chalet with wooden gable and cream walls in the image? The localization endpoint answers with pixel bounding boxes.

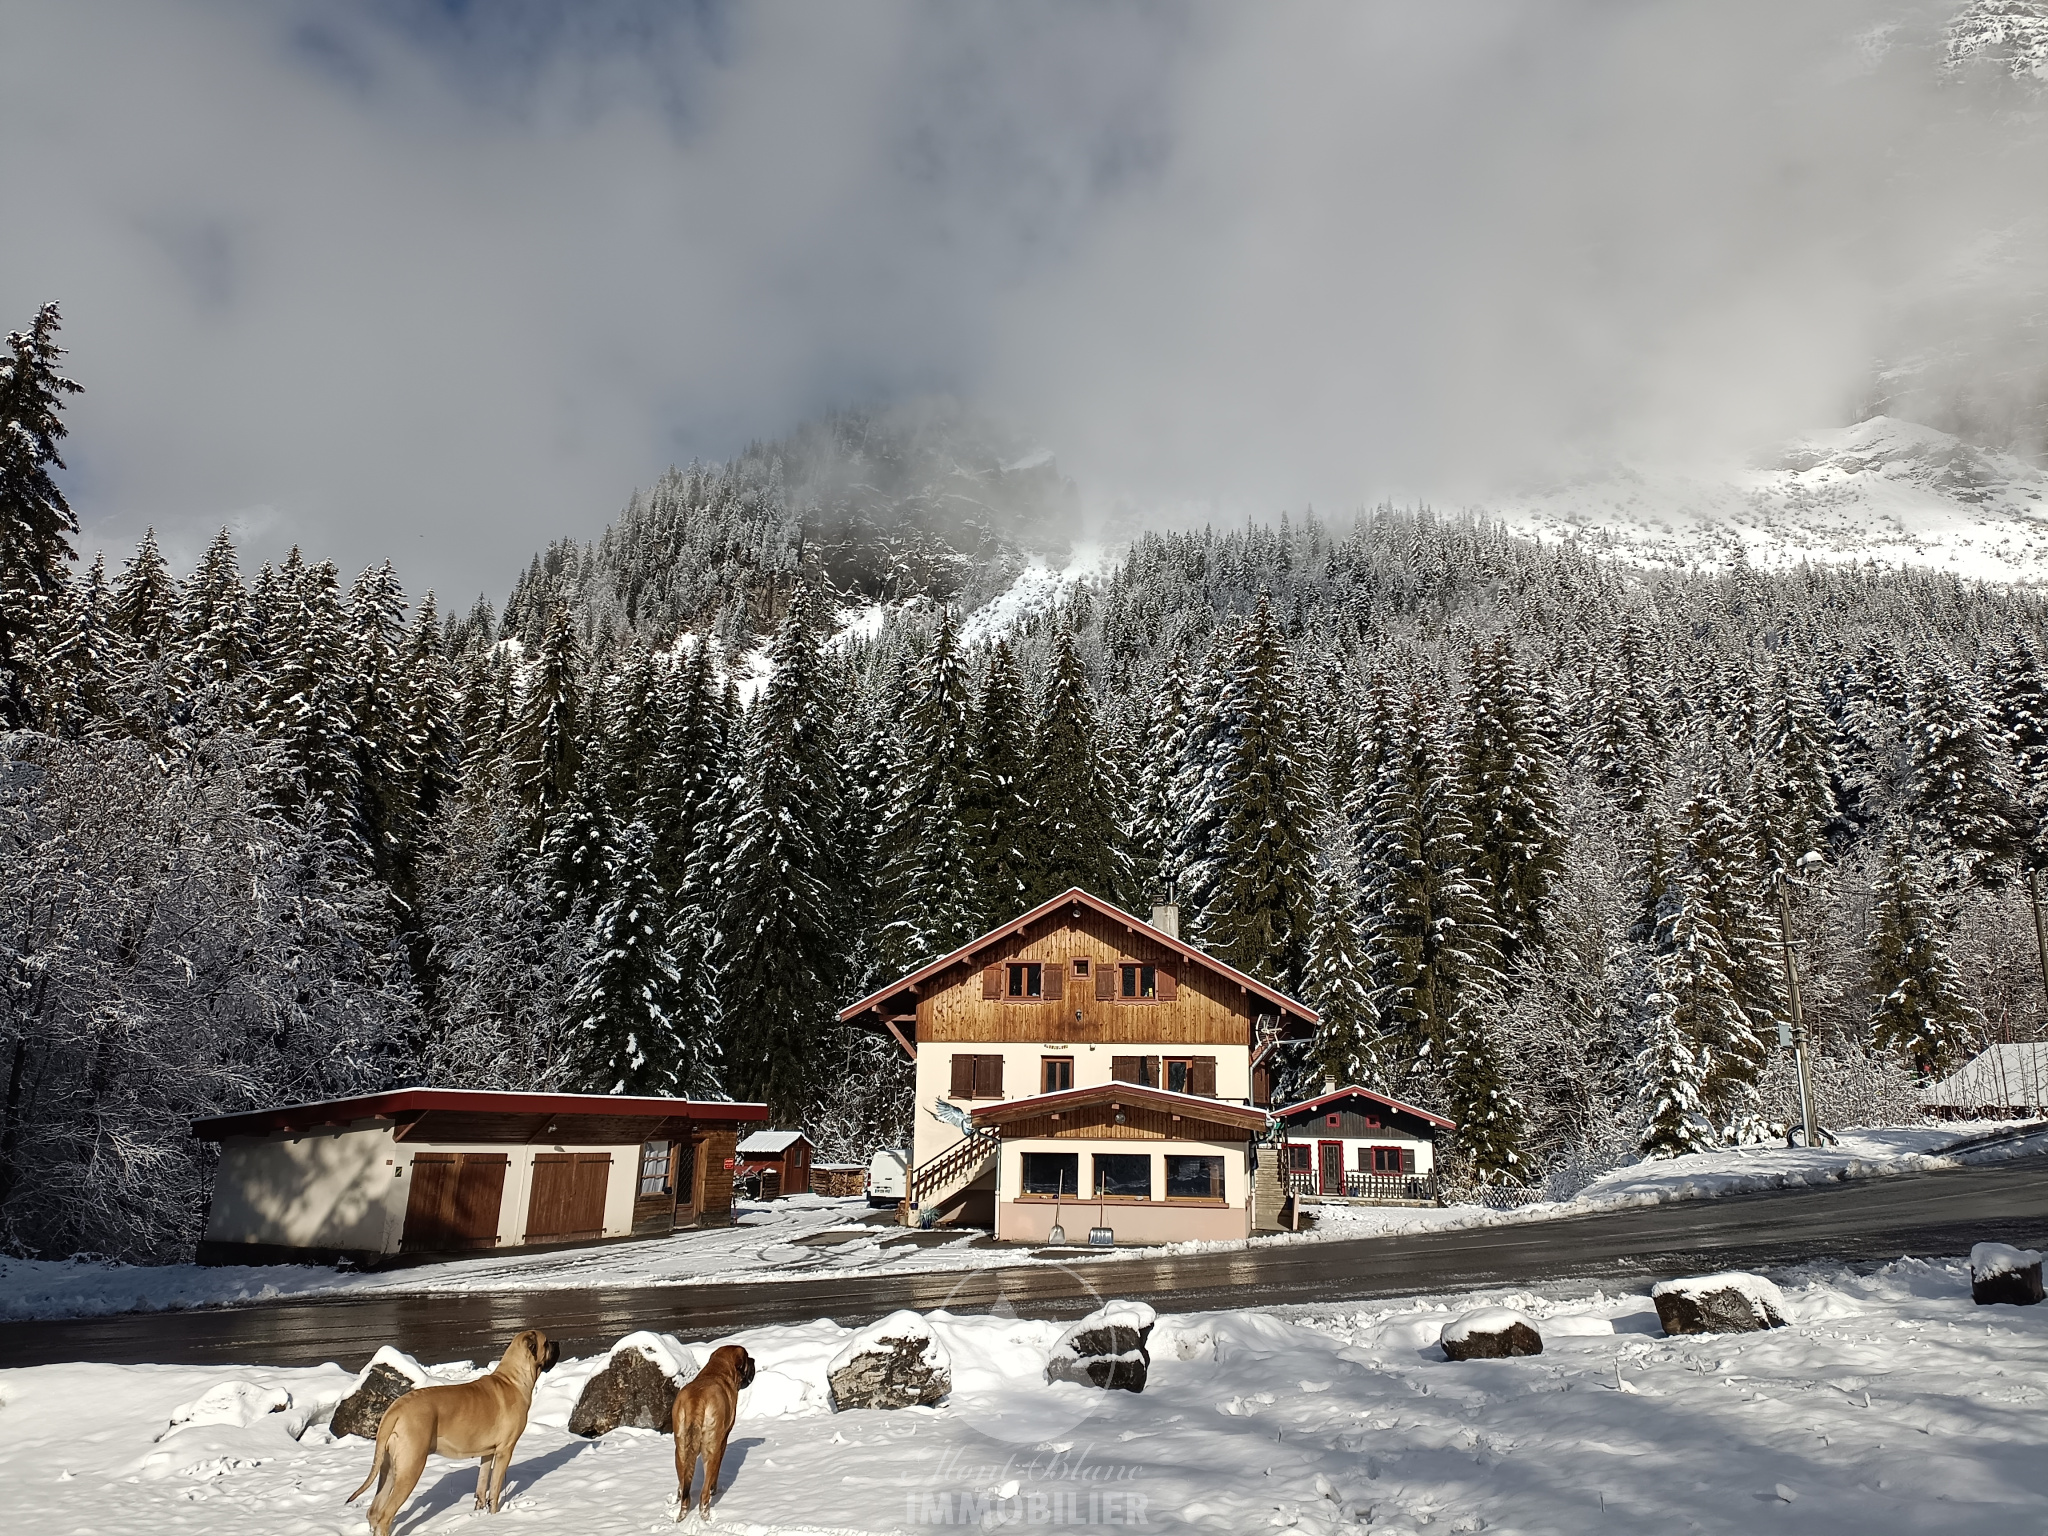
[840,889,1317,1243]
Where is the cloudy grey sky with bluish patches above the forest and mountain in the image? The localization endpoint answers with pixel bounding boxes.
[0,0,2048,602]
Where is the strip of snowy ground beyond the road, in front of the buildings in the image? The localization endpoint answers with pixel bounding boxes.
[0,1120,2048,1319]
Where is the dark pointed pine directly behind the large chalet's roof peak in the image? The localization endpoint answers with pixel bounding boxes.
[1024,625,1133,905]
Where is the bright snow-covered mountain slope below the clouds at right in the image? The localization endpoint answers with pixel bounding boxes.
[1475,416,2048,584]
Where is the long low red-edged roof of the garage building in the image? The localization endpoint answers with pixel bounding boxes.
[193,1087,768,1147]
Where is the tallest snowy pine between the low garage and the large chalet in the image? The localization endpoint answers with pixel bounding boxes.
[719,582,842,1122]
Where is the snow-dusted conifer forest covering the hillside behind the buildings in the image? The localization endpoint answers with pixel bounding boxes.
[0,307,2048,1260]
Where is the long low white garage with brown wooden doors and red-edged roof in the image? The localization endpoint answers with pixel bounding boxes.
[193,1087,768,1266]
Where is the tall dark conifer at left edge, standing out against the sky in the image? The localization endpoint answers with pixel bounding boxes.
[0,303,80,729]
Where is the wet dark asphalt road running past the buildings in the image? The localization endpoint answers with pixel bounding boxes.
[0,1157,2048,1368]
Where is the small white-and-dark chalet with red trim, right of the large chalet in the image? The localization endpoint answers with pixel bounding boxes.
[1274,1083,1458,1204]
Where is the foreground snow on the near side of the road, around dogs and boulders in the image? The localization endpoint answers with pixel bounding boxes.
[12,1260,2048,1536]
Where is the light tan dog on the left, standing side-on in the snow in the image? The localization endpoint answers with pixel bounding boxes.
[346,1329,561,1536]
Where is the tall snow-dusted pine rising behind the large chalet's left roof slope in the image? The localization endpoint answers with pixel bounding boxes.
[877,608,983,975]
